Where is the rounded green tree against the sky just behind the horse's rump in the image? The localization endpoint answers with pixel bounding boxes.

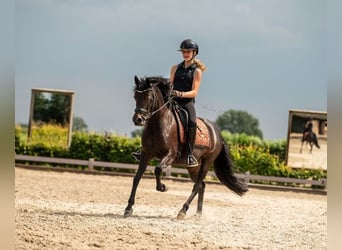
[215,109,263,139]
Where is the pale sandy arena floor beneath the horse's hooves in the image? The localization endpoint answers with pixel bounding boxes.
[15,168,327,249]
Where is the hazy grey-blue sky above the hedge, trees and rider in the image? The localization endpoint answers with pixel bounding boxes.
[15,0,327,140]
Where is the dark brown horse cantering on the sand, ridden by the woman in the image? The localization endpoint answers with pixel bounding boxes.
[124,76,248,219]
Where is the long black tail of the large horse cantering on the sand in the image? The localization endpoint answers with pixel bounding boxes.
[214,142,248,196]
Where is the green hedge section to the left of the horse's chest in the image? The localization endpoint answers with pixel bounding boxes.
[15,127,140,163]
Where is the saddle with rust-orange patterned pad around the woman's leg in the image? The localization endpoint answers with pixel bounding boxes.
[172,103,210,148]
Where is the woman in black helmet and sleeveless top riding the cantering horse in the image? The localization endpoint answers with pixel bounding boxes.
[132,39,207,167]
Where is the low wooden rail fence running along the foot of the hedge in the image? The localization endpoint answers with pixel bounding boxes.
[15,155,327,190]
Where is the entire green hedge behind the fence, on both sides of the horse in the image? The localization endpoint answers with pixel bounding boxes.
[15,127,327,183]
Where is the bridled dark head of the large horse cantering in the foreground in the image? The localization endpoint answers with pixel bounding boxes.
[133,76,169,126]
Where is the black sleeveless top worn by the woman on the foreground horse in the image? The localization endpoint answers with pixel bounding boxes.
[173,61,197,104]
